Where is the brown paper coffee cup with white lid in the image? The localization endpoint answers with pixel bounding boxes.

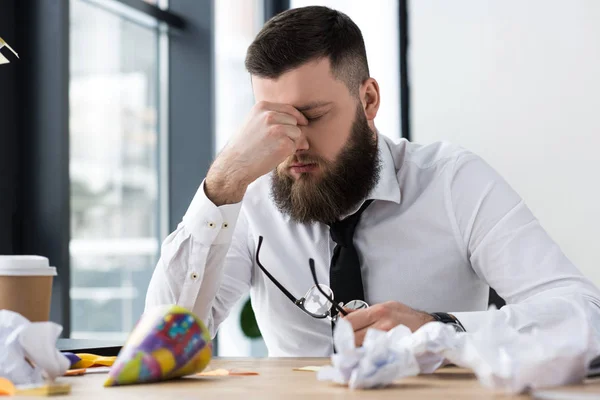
[0,256,56,322]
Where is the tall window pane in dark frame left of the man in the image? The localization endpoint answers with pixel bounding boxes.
[69,0,166,340]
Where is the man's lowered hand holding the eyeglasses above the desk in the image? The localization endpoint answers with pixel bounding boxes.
[343,301,435,346]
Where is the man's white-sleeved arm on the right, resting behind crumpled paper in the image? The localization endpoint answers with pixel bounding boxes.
[447,153,600,331]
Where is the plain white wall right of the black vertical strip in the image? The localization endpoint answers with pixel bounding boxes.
[409,0,600,284]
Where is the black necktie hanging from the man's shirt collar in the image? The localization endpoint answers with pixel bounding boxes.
[329,200,373,311]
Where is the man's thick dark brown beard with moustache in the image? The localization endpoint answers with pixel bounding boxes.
[271,104,381,224]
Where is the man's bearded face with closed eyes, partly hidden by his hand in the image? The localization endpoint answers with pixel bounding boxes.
[253,59,379,223]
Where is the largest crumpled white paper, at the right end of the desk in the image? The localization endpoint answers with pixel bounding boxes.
[443,297,600,393]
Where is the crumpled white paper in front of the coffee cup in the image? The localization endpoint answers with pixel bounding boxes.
[0,310,70,385]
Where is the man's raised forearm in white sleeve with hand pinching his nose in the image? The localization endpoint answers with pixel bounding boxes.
[146,102,308,335]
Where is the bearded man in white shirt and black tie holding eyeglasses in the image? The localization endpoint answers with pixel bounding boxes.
[146,6,600,356]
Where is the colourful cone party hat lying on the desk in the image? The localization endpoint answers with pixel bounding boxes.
[104,305,212,386]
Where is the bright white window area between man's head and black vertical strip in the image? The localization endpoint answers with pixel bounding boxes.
[290,0,402,139]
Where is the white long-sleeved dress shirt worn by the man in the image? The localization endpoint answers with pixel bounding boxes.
[146,135,600,356]
